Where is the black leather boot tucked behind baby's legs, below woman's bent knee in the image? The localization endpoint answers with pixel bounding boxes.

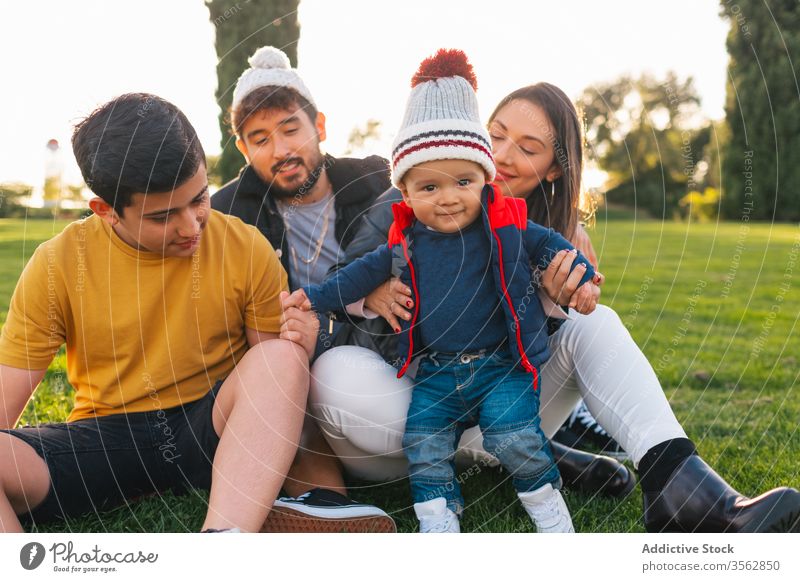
[550,441,636,497]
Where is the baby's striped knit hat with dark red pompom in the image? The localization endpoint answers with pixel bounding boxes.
[392,49,495,187]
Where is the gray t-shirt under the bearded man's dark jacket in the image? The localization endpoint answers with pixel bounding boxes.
[277,192,342,285]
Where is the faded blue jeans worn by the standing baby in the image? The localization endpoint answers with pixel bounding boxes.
[403,351,561,513]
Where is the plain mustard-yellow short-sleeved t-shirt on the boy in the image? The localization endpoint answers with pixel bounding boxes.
[0,211,287,421]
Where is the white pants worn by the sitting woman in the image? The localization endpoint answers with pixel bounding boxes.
[309,305,686,481]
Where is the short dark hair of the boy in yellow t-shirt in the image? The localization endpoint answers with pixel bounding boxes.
[72,93,206,216]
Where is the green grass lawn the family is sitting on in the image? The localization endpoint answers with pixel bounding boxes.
[0,212,800,532]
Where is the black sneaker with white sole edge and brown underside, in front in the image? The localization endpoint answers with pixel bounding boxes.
[261,489,397,533]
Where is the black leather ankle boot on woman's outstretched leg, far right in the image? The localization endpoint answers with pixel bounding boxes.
[644,455,800,533]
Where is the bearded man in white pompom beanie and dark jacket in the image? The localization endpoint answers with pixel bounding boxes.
[211,47,394,531]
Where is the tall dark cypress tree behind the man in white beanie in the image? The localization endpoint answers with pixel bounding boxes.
[206,0,300,184]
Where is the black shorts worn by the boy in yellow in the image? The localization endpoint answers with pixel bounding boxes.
[2,381,222,523]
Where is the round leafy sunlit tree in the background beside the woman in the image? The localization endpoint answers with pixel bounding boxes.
[578,72,710,217]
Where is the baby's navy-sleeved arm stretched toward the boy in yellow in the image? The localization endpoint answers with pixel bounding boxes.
[304,244,393,320]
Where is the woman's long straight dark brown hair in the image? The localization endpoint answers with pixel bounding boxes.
[489,83,583,239]
